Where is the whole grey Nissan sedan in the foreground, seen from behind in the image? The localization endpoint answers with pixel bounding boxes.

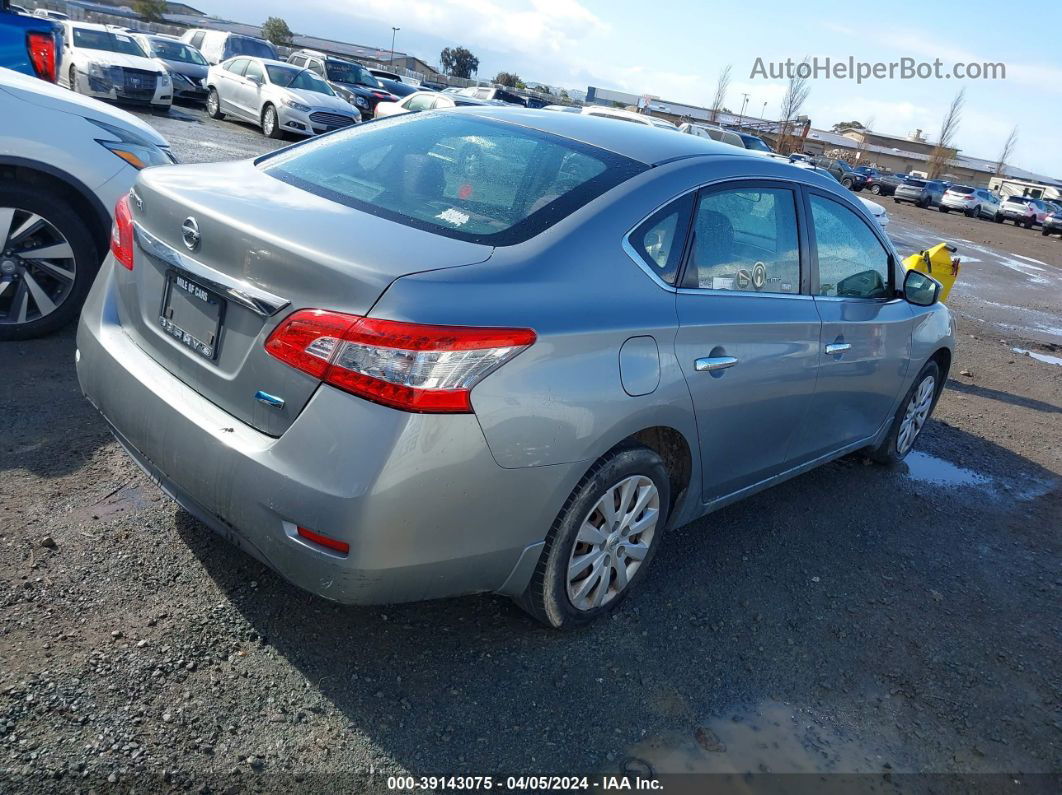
[78,107,954,627]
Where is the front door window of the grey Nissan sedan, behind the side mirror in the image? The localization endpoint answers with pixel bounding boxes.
[810,194,891,298]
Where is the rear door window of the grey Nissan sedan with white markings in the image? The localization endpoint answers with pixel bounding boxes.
[683,188,800,294]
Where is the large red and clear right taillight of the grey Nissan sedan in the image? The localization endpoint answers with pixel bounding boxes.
[266,309,535,414]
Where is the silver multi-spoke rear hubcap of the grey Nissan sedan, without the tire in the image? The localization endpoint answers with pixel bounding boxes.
[568,474,661,610]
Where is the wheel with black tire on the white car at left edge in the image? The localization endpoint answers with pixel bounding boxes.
[0,182,100,340]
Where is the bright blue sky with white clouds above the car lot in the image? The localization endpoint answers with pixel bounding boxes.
[209,0,1062,178]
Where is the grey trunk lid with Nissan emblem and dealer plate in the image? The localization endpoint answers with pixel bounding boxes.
[116,161,493,436]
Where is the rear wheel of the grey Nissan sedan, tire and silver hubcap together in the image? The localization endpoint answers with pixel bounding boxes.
[519,445,670,629]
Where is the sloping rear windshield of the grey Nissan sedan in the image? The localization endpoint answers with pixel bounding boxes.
[260,111,647,245]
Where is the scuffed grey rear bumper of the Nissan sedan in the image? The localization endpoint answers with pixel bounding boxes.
[78,257,585,604]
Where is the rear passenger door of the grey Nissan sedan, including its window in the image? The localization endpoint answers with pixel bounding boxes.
[675,180,819,502]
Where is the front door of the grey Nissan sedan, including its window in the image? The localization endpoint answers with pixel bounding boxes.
[791,189,914,465]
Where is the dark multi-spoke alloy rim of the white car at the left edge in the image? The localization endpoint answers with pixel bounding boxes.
[0,207,78,325]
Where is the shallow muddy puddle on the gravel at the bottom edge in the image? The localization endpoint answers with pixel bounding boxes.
[620,702,897,775]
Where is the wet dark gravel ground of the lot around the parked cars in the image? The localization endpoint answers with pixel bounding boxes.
[0,105,1062,792]
